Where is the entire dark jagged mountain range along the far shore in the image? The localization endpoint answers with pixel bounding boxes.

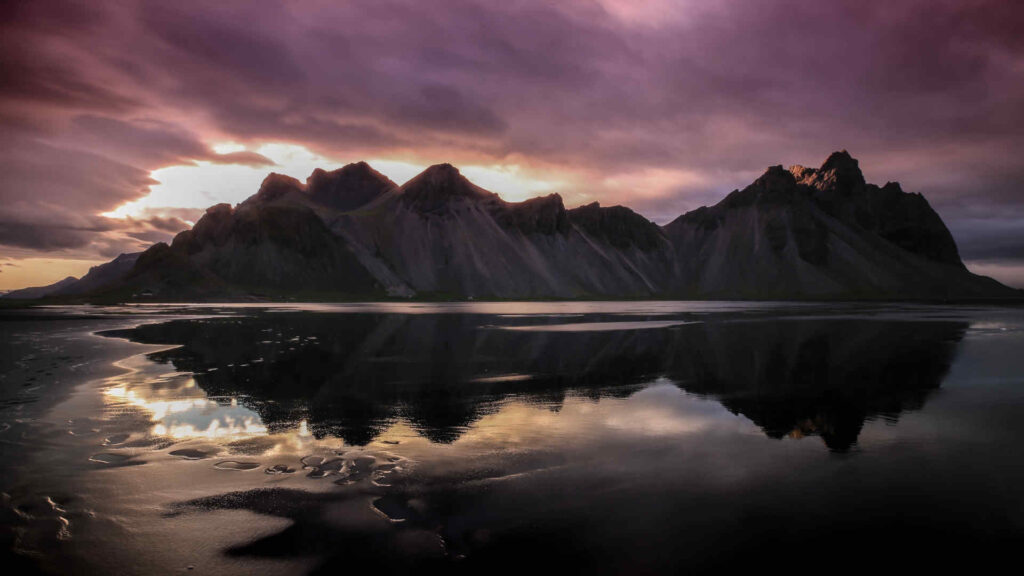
[5,151,1021,300]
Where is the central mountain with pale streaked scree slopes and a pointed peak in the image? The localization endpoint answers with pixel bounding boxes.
[331,164,672,298]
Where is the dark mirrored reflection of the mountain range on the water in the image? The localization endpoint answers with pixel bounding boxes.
[109,313,967,451]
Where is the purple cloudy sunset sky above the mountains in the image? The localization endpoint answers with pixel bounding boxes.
[0,0,1024,289]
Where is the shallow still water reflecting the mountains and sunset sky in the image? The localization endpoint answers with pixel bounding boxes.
[0,302,1024,574]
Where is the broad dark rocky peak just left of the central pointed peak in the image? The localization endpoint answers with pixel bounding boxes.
[306,162,398,211]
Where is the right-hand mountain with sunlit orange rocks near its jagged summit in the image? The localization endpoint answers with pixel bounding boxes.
[665,152,1016,299]
